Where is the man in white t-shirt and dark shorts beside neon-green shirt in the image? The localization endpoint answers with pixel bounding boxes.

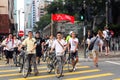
[68,32,78,71]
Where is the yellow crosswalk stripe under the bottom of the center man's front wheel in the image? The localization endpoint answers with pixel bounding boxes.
[10,69,100,80]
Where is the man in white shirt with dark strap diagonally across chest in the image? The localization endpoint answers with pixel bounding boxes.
[50,32,66,78]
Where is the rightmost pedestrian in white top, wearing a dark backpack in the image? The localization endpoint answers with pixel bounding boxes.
[103,26,110,56]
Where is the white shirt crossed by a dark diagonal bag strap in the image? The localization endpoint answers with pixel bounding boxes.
[52,39,66,55]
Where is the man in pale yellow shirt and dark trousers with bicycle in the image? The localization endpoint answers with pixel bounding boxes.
[19,31,39,76]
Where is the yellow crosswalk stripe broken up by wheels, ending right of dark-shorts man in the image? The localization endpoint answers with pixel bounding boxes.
[0,66,89,77]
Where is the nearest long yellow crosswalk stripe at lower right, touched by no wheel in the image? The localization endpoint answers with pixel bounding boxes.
[64,73,113,80]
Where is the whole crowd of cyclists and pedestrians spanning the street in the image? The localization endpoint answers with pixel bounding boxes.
[1,27,111,77]
